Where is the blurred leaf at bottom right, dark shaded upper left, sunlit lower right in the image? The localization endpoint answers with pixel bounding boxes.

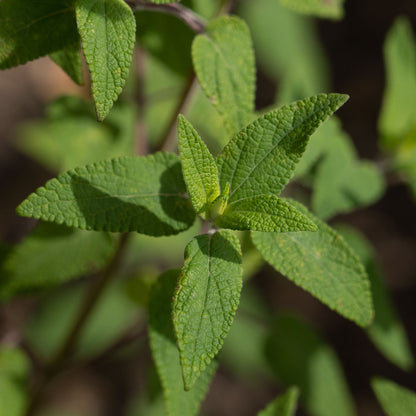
[265,315,355,416]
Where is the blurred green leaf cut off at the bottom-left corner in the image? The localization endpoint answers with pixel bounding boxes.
[0,346,30,416]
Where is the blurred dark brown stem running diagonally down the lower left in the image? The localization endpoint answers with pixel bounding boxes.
[26,233,129,416]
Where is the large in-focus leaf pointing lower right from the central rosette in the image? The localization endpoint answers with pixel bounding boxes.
[252,201,373,326]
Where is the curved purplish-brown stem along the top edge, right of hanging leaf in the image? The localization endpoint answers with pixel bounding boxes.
[127,0,205,33]
